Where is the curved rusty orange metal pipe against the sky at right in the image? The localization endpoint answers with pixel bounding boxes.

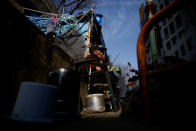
[137,0,183,120]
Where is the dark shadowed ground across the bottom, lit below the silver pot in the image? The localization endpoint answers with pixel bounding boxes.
[1,112,181,131]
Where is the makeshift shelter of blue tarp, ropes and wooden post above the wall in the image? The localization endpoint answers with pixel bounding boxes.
[26,9,107,61]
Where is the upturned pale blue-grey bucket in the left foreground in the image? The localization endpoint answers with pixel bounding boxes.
[11,82,57,123]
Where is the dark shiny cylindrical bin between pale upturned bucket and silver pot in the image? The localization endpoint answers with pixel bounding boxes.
[48,68,80,118]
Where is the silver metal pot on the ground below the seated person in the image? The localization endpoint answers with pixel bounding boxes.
[85,94,105,113]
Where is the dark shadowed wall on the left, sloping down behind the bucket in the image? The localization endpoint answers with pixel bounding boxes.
[0,2,73,116]
